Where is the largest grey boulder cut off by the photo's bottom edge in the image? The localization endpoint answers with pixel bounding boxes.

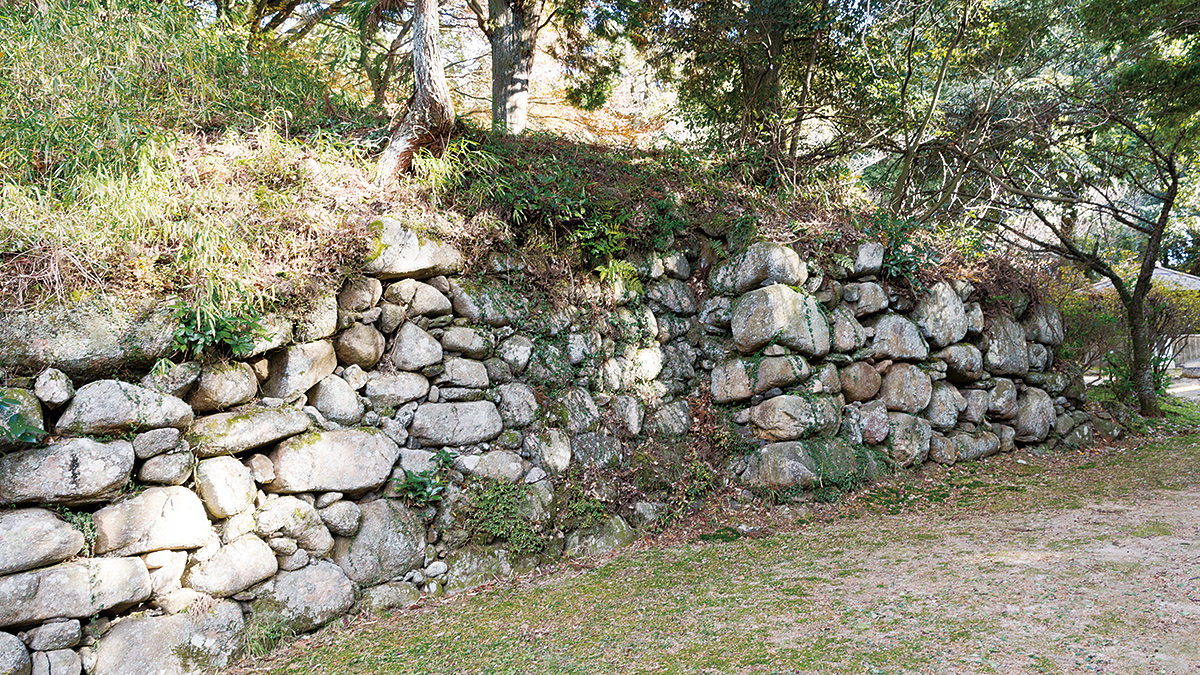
[86,601,245,675]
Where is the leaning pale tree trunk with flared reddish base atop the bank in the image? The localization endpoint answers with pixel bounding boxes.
[376,0,454,187]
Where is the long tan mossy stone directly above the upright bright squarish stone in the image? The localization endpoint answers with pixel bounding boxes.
[185,408,312,458]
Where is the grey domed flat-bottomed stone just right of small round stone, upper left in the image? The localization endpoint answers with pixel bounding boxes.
[55,380,193,435]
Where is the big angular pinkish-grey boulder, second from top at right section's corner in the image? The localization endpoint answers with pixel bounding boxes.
[731,283,829,357]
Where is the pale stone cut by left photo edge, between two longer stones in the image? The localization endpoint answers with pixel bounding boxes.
[0,508,84,575]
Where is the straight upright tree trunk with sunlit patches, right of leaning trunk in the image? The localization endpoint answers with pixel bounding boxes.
[486,0,541,133]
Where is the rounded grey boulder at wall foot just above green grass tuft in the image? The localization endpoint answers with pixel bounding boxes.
[251,561,354,633]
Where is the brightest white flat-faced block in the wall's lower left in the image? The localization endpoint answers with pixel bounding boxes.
[92,486,212,555]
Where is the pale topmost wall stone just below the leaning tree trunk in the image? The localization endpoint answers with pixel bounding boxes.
[362,214,463,280]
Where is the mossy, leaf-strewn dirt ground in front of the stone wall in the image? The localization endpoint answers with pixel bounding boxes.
[231,436,1200,675]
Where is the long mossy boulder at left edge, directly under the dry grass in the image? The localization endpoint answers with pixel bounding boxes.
[0,298,179,381]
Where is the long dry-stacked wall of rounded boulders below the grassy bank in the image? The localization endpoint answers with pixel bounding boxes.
[0,219,1091,675]
